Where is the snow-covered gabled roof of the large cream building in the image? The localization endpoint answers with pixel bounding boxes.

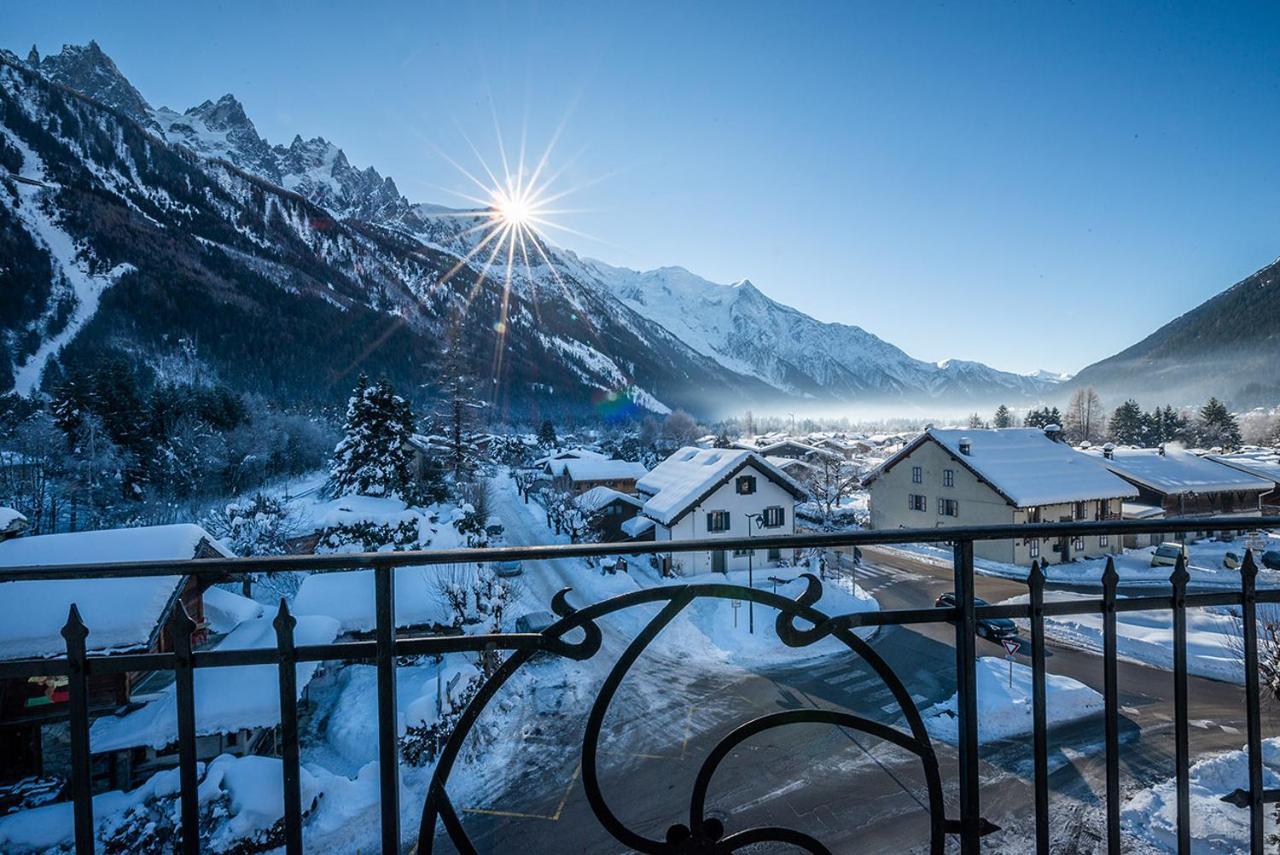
[863,428,1138,508]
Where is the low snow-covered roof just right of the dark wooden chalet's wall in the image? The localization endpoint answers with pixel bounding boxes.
[90,614,338,751]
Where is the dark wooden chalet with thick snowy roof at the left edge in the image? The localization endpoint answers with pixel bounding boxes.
[0,525,230,786]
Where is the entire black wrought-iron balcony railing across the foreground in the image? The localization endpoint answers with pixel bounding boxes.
[0,517,1280,854]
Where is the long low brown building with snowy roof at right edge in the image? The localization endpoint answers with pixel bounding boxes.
[1083,443,1275,535]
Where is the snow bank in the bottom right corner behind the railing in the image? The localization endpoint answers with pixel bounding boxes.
[1120,739,1280,855]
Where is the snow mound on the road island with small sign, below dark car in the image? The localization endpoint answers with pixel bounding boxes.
[924,657,1103,742]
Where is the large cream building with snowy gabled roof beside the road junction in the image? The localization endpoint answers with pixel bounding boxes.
[863,428,1138,564]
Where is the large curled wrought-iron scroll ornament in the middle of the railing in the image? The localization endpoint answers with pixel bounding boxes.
[417,573,948,854]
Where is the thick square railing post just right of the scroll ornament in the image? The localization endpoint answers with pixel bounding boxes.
[954,540,980,855]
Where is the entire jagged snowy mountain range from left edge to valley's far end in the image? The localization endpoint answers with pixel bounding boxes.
[0,42,1275,417]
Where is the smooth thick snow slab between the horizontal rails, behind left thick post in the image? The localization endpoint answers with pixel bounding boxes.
[293,567,453,632]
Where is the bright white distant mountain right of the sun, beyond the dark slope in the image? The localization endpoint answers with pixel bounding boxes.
[580,260,1053,401]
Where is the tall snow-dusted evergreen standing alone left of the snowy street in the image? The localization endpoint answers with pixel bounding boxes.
[329,375,415,499]
